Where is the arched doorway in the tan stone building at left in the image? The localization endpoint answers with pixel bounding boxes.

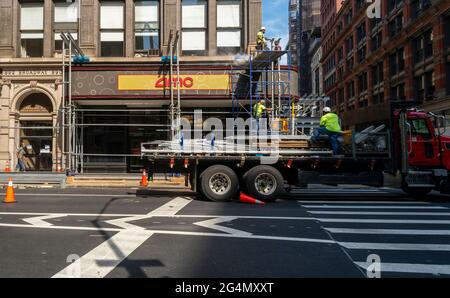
[17,93,55,171]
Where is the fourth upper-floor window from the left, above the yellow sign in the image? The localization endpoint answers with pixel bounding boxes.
[134,1,159,55]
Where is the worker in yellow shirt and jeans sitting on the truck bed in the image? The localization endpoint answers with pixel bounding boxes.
[311,107,342,155]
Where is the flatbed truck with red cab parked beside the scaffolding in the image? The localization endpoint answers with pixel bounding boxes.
[141,101,450,202]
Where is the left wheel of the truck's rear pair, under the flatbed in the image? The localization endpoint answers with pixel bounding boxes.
[199,165,239,202]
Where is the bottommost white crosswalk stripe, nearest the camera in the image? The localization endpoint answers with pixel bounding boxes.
[355,262,450,274]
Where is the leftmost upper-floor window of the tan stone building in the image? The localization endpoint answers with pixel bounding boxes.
[20,3,44,57]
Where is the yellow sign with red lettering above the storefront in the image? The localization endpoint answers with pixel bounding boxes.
[117,74,230,91]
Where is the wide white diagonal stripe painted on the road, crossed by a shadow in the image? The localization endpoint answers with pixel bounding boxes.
[53,197,191,278]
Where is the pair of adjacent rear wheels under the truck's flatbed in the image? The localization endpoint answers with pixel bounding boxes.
[199,165,284,202]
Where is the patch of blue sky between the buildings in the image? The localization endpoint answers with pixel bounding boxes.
[263,0,289,49]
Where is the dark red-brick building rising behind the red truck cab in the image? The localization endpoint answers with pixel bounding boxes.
[322,0,450,128]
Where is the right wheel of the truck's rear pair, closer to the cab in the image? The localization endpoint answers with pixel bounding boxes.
[244,165,284,202]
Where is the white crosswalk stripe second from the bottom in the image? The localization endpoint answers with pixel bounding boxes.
[337,242,450,251]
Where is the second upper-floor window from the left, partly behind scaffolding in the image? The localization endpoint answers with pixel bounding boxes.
[54,0,79,51]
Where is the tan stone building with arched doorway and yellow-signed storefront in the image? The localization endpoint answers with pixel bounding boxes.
[0,0,298,172]
